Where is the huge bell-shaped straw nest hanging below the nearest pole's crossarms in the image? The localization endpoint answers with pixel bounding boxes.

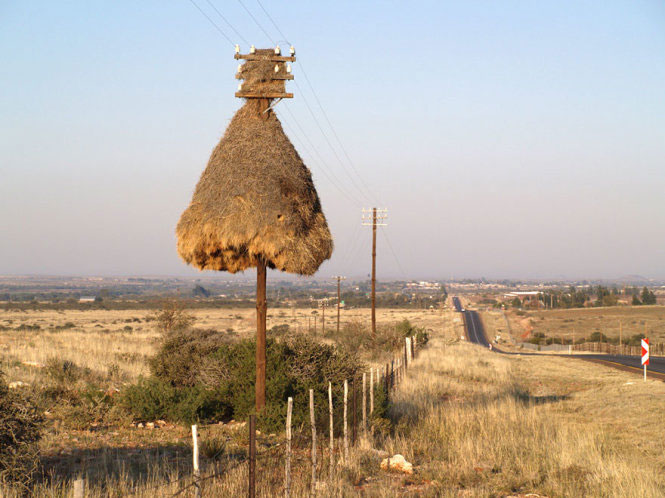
[176,100,333,275]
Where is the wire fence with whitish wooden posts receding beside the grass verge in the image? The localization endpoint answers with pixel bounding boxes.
[79,336,423,498]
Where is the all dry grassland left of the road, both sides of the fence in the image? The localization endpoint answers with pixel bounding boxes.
[0,310,665,497]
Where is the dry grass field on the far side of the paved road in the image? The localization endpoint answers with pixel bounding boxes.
[483,306,665,342]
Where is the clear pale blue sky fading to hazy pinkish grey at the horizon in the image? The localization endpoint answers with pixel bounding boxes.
[0,0,665,279]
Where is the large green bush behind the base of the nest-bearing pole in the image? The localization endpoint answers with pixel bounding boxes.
[122,331,362,431]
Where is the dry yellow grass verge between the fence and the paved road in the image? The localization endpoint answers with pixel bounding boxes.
[386,320,665,497]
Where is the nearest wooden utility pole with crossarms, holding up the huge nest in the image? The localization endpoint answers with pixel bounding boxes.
[235,45,296,413]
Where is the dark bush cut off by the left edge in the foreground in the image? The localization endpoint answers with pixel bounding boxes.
[0,375,42,490]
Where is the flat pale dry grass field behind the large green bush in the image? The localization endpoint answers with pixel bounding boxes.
[0,308,443,383]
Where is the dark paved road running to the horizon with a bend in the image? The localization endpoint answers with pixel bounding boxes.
[453,297,665,380]
